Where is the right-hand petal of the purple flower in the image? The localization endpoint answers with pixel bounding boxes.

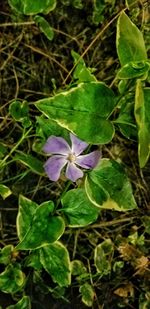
[76,150,101,169]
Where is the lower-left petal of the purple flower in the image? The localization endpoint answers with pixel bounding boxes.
[44,155,67,181]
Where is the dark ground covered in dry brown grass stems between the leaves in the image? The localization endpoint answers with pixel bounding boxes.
[0,0,150,309]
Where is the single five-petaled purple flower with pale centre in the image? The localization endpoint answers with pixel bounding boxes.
[43,133,101,181]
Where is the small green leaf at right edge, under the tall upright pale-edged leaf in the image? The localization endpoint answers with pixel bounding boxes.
[117,61,149,79]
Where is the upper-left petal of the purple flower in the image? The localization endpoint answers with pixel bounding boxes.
[43,135,71,155]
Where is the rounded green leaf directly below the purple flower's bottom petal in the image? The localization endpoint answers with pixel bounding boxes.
[62,185,99,227]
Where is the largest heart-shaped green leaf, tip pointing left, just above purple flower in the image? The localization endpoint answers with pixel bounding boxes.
[35,82,116,144]
